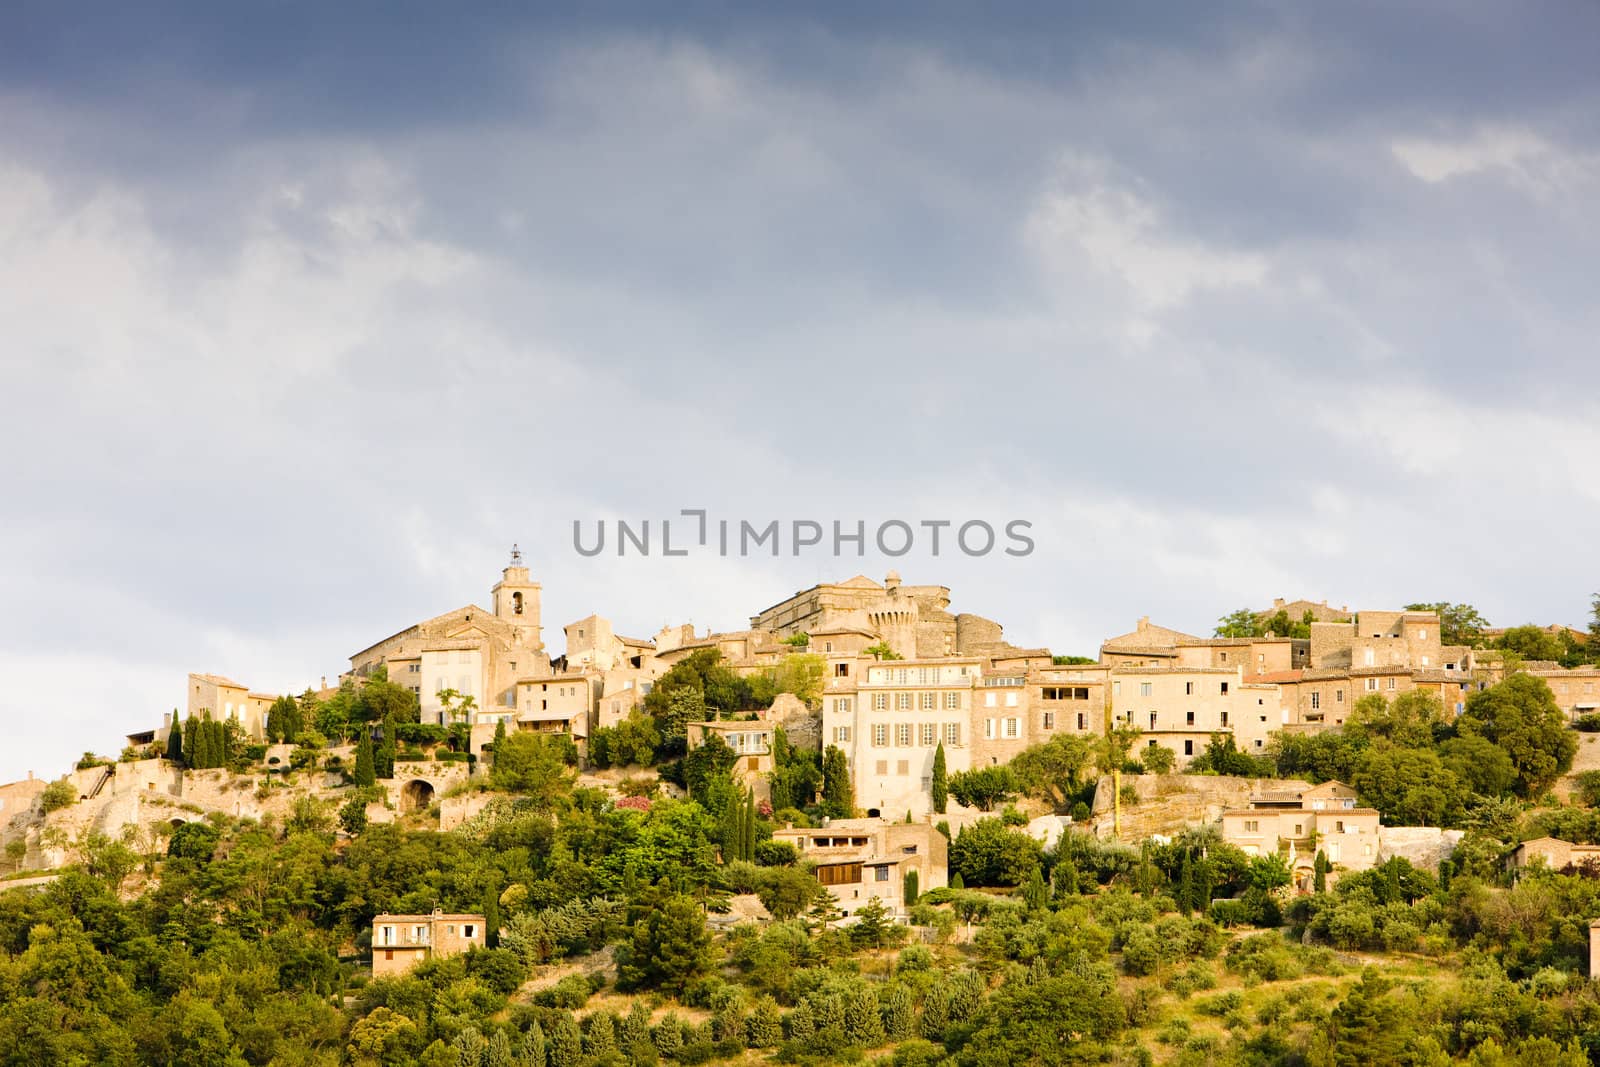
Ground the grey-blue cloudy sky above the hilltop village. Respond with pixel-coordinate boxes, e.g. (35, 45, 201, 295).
(0, 2, 1600, 781)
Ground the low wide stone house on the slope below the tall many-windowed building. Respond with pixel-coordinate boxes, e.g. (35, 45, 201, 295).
(773, 819, 949, 917)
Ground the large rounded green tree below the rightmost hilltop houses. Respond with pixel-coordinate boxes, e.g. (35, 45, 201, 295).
(1456, 673, 1578, 797)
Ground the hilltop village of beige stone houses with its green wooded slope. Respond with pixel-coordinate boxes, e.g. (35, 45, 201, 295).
(0, 550, 1600, 1067)
